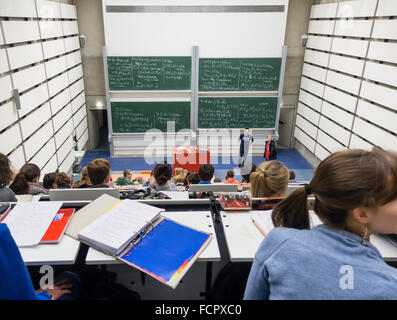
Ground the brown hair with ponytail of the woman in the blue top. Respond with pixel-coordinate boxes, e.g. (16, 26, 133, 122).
(272, 147, 397, 229)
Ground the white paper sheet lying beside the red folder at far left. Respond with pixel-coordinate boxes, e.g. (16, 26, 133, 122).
(3, 201, 62, 247)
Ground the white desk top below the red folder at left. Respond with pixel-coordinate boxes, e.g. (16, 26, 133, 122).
(19, 234, 80, 266)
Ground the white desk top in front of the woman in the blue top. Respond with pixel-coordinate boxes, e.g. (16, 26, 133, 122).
(221, 211, 397, 262)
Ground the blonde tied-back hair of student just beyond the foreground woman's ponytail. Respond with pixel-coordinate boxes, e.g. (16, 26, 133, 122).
(250, 161, 289, 198)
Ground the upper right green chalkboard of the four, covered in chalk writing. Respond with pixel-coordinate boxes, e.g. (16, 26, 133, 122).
(199, 58, 281, 91)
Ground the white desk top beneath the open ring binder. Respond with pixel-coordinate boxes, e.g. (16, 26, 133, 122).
(86, 211, 221, 264)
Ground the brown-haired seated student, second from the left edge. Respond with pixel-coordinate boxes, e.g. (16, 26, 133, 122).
(10, 163, 48, 195)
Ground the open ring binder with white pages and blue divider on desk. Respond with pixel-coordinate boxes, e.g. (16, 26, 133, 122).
(66, 195, 212, 288)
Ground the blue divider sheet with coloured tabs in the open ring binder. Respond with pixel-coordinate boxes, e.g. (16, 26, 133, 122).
(119, 219, 211, 287)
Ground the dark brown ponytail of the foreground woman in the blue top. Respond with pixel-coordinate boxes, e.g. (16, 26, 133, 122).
(272, 185, 311, 229)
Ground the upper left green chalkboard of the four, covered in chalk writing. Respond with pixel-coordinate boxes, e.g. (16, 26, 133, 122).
(107, 56, 192, 91)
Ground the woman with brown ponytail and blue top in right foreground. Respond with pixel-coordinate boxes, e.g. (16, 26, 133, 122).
(244, 148, 397, 300)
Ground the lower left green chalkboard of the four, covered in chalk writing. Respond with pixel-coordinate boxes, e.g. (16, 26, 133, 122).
(110, 101, 190, 133)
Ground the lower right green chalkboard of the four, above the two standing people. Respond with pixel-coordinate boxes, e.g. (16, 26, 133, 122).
(198, 97, 277, 128)
